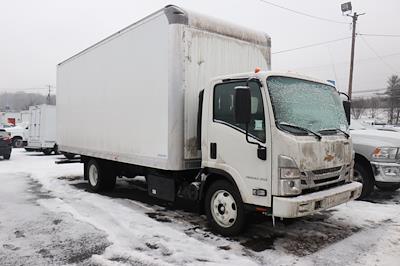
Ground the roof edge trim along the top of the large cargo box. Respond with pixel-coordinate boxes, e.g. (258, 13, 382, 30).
(58, 5, 271, 66)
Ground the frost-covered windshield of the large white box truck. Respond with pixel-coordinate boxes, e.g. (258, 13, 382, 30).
(267, 76, 348, 134)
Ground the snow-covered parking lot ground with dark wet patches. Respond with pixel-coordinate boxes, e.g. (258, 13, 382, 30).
(0, 149, 400, 265)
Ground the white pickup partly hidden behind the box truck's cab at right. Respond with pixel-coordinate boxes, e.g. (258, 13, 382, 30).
(350, 121, 400, 198)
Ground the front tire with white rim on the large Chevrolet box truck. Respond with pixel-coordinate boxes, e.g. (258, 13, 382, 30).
(204, 180, 245, 236)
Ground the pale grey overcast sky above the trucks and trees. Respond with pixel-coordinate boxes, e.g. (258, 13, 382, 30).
(0, 0, 400, 96)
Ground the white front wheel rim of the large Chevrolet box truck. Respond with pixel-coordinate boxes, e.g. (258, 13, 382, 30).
(211, 190, 237, 228)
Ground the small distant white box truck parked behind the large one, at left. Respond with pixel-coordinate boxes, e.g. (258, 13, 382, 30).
(25, 104, 58, 155)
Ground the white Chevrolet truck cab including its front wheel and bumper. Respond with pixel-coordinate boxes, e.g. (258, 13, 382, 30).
(200, 71, 362, 234)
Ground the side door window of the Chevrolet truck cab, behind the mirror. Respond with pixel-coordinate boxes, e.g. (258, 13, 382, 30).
(213, 81, 265, 142)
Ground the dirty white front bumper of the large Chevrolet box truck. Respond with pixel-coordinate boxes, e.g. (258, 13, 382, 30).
(272, 182, 362, 218)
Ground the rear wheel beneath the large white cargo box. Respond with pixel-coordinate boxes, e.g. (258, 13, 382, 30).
(85, 159, 116, 192)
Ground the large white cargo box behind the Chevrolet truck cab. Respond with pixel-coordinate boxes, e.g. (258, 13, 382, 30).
(57, 6, 271, 170)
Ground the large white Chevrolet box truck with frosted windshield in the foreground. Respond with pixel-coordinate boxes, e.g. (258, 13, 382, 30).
(57, 6, 362, 235)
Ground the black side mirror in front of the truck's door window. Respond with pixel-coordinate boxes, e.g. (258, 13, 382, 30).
(234, 86, 251, 125)
